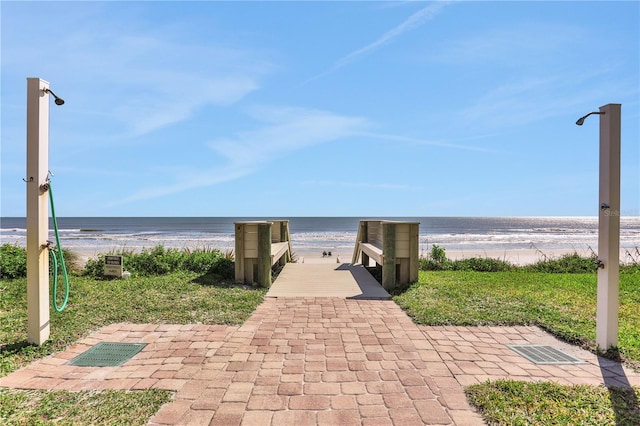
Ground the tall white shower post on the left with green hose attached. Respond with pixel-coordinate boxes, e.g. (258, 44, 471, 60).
(26, 78, 49, 345)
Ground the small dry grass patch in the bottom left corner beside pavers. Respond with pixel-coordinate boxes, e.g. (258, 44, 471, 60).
(0, 389, 171, 425)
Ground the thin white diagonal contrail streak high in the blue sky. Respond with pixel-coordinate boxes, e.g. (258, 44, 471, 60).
(302, 1, 451, 84)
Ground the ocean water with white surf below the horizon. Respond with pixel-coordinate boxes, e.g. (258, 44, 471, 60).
(0, 217, 640, 260)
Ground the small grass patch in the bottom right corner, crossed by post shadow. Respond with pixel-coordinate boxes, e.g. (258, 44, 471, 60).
(465, 380, 640, 426)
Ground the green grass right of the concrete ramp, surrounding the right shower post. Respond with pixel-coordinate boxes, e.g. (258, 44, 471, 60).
(394, 271, 640, 368)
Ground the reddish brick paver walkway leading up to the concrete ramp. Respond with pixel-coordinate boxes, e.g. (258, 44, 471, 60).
(0, 298, 640, 426)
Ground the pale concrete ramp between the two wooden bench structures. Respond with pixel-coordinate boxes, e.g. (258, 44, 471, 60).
(266, 263, 391, 299)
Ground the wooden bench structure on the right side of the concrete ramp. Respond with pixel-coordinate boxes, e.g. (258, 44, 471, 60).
(352, 220, 420, 290)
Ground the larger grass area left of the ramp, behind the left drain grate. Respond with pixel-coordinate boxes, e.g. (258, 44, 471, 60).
(0, 272, 266, 377)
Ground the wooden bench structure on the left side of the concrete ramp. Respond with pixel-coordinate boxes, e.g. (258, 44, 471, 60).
(234, 220, 291, 287)
